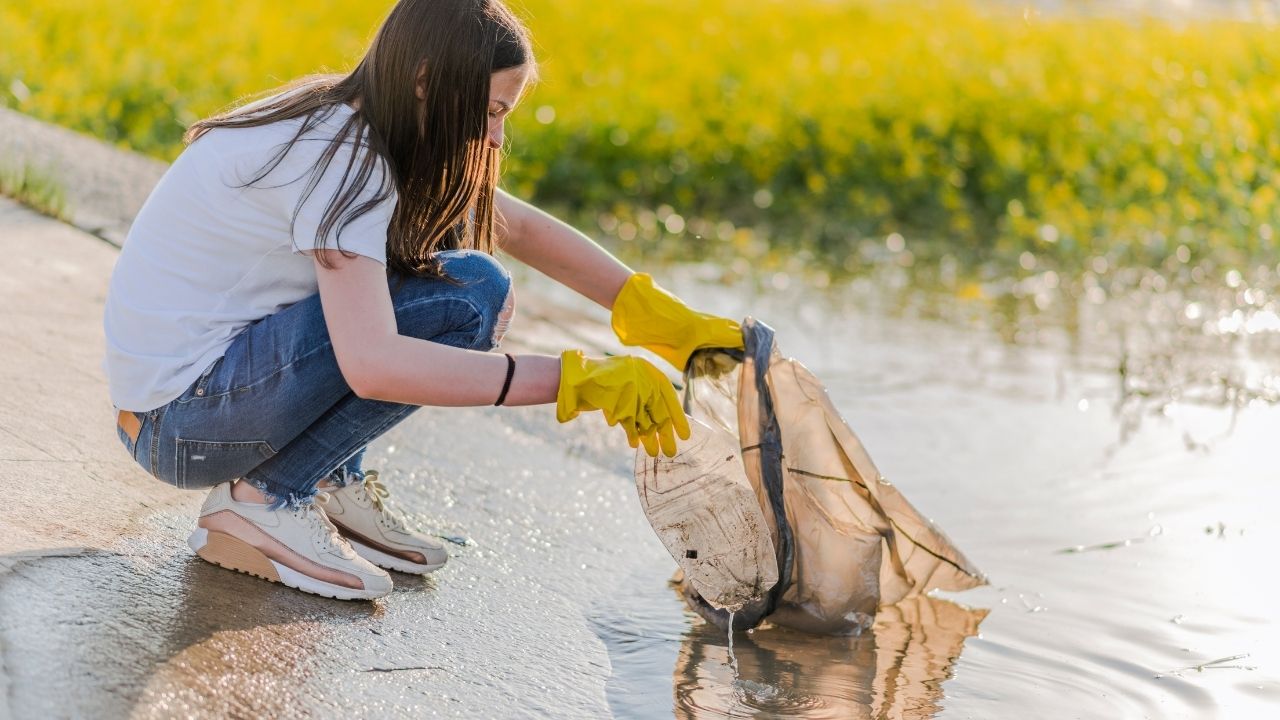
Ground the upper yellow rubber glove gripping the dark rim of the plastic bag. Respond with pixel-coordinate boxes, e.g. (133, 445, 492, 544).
(612, 273, 742, 372)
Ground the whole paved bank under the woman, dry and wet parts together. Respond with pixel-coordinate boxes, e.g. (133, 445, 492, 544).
(0, 116, 673, 717)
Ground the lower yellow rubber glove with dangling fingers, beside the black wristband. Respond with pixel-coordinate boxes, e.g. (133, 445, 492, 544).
(556, 350, 689, 457)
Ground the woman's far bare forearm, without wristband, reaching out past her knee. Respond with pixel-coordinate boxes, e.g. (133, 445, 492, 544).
(494, 190, 635, 307)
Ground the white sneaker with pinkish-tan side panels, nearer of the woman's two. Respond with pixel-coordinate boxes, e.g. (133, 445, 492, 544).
(187, 483, 392, 600)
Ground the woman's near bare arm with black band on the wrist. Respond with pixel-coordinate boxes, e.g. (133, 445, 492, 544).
(315, 250, 561, 406)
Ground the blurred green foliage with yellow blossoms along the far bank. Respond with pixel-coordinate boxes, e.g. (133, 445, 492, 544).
(0, 0, 1280, 269)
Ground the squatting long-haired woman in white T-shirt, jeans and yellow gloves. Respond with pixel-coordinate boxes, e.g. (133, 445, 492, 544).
(104, 0, 741, 598)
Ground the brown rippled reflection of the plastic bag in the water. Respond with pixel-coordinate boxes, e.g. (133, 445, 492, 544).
(675, 597, 987, 719)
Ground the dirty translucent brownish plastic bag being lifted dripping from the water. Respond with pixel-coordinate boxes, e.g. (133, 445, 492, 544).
(635, 318, 986, 633)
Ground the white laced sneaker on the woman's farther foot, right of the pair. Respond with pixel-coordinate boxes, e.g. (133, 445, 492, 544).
(324, 470, 449, 575)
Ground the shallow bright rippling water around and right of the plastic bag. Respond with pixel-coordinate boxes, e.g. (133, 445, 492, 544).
(583, 265, 1280, 719)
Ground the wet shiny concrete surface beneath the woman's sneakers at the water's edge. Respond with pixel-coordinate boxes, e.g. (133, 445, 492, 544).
(0, 410, 663, 717)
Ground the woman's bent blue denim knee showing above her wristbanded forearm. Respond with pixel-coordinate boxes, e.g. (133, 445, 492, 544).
(393, 250, 515, 350)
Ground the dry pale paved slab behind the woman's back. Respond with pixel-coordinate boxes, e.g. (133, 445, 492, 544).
(0, 200, 192, 550)
